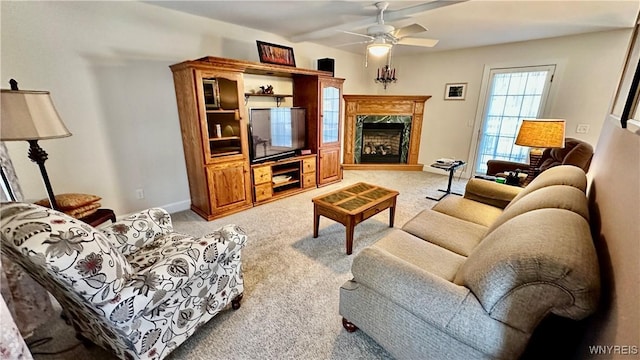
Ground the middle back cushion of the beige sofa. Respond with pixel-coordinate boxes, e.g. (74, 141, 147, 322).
(487, 185, 589, 234)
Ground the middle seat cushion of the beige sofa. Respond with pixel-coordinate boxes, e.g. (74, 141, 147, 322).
(402, 209, 487, 256)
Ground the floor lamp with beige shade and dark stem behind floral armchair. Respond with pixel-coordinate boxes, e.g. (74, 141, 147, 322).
(0, 79, 71, 209)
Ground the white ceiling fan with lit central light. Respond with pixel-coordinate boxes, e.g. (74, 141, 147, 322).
(338, 1, 438, 56)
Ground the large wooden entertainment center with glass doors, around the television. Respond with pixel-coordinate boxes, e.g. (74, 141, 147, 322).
(170, 56, 344, 220)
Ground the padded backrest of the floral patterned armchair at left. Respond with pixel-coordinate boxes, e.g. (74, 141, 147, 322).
(0, 203, 134, 303)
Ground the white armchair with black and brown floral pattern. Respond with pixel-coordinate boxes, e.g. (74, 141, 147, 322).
(0, 203, 247, 359)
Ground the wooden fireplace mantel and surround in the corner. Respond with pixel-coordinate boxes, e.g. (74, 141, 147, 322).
(342, 95, 431, 171)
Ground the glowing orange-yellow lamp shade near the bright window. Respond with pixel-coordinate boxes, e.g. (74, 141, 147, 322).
(516, 119, 565, 148)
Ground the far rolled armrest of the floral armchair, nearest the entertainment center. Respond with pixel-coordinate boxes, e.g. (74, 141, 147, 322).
(100, 208, 173, 255)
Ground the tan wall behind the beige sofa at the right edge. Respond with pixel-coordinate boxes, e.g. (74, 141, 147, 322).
(575, 117, 640, 359)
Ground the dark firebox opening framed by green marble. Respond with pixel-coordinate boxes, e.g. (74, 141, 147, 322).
(360, 123, 404, 164)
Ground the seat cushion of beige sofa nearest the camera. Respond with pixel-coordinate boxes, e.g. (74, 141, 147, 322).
(372, 229, 466, 281)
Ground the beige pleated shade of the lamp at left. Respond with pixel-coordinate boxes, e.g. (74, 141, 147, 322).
(0, 89, 71, 141)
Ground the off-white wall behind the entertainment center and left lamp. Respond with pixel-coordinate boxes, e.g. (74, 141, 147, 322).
(0, 1, 366, 214)
